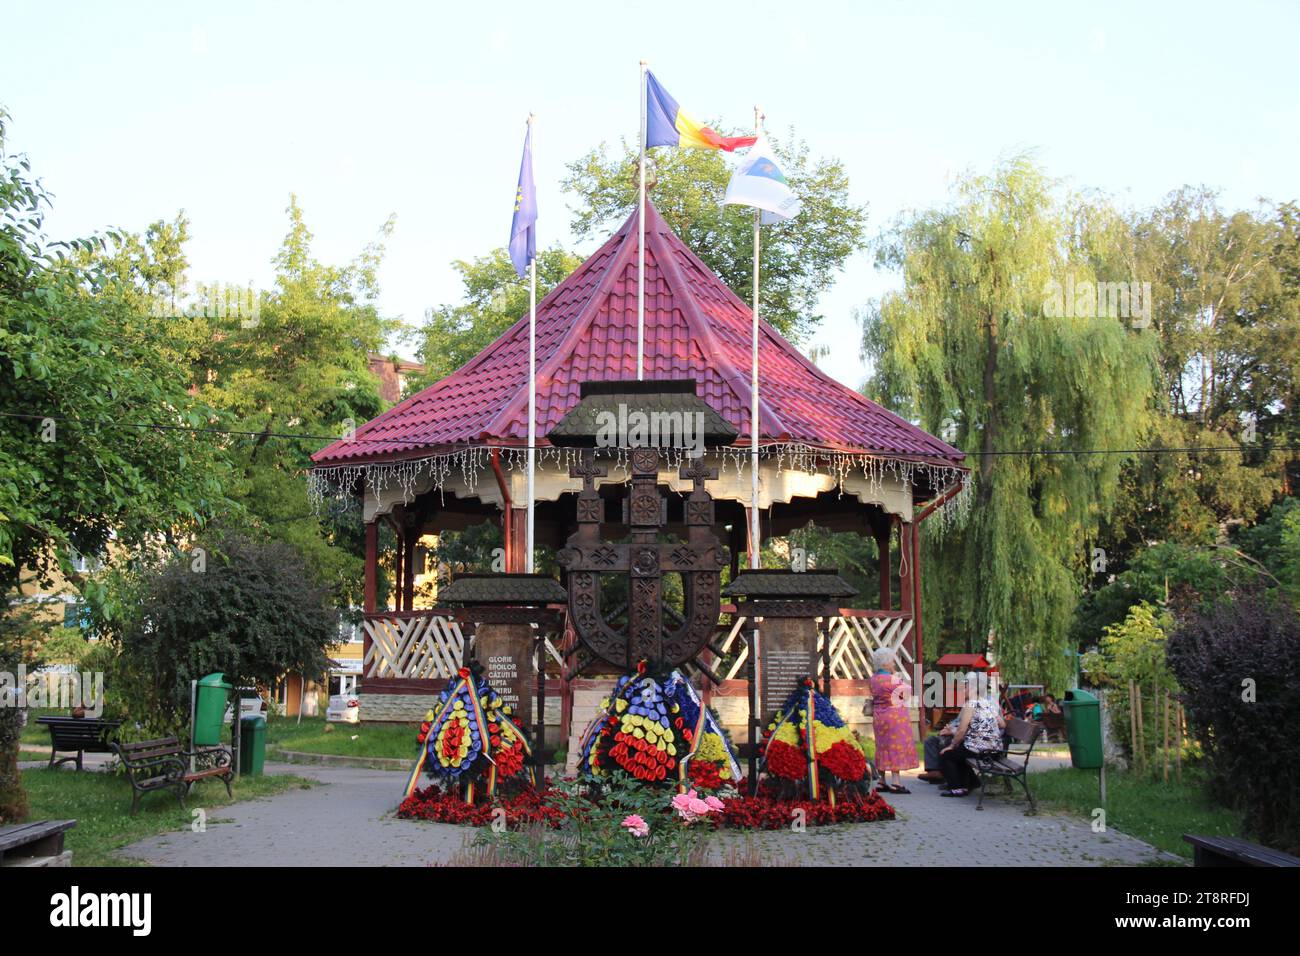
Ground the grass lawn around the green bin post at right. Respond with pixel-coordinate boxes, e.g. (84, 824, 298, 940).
(1030, 767, 1248, 860)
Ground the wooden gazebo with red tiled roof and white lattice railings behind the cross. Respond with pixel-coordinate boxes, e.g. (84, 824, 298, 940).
(311, 203, 966, 734)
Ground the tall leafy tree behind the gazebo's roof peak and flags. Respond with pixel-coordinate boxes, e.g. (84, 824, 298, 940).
(564, 131, 867, 342)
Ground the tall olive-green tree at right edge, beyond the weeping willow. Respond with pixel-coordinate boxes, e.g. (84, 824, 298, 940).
(1100, 187, 1300, 567)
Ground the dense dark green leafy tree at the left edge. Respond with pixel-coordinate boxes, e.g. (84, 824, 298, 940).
(0, 108, 229, 607)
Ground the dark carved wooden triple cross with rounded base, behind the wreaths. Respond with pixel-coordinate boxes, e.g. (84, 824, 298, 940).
(556, 447, 729, 670)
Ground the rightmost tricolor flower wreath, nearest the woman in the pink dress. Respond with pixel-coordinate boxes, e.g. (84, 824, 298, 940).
(762, 679, 871, 801)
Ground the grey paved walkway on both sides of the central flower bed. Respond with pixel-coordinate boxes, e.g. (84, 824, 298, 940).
(114, 761, 1175, 866)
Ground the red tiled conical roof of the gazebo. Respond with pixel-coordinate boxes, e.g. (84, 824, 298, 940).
(312, 203, 963, 466)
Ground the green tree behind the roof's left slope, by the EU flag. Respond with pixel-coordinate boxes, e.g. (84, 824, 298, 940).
(407, 246, 582, 394)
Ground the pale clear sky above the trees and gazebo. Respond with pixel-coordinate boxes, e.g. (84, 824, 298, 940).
(0, 0, 1300, 386)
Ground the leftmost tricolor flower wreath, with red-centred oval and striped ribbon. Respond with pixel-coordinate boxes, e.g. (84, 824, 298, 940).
(406, 667, 533, 804)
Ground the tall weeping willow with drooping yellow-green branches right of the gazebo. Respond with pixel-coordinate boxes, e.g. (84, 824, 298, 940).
(863, 157, 1154, 688)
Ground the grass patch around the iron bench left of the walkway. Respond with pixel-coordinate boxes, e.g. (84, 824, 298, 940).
(22, 769, 313, 866)
